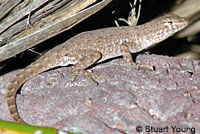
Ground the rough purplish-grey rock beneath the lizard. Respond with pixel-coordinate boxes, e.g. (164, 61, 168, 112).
(0, 55, 200, 134)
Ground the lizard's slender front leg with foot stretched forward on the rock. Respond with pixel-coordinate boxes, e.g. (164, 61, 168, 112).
(120, 43, 154, 70)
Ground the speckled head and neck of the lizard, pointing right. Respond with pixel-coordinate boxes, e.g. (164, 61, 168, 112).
(141, 13, 188, 47)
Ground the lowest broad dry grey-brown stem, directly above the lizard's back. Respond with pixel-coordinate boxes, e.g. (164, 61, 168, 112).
(0, 0, 112, 62)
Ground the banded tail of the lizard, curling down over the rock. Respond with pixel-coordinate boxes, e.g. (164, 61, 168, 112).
(6, 58, 50, 124)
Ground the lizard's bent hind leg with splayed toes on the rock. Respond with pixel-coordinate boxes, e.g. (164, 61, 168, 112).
(71, 51, 103, 85)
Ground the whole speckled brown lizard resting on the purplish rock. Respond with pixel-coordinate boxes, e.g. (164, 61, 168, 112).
(6, 13, 188, 123)
